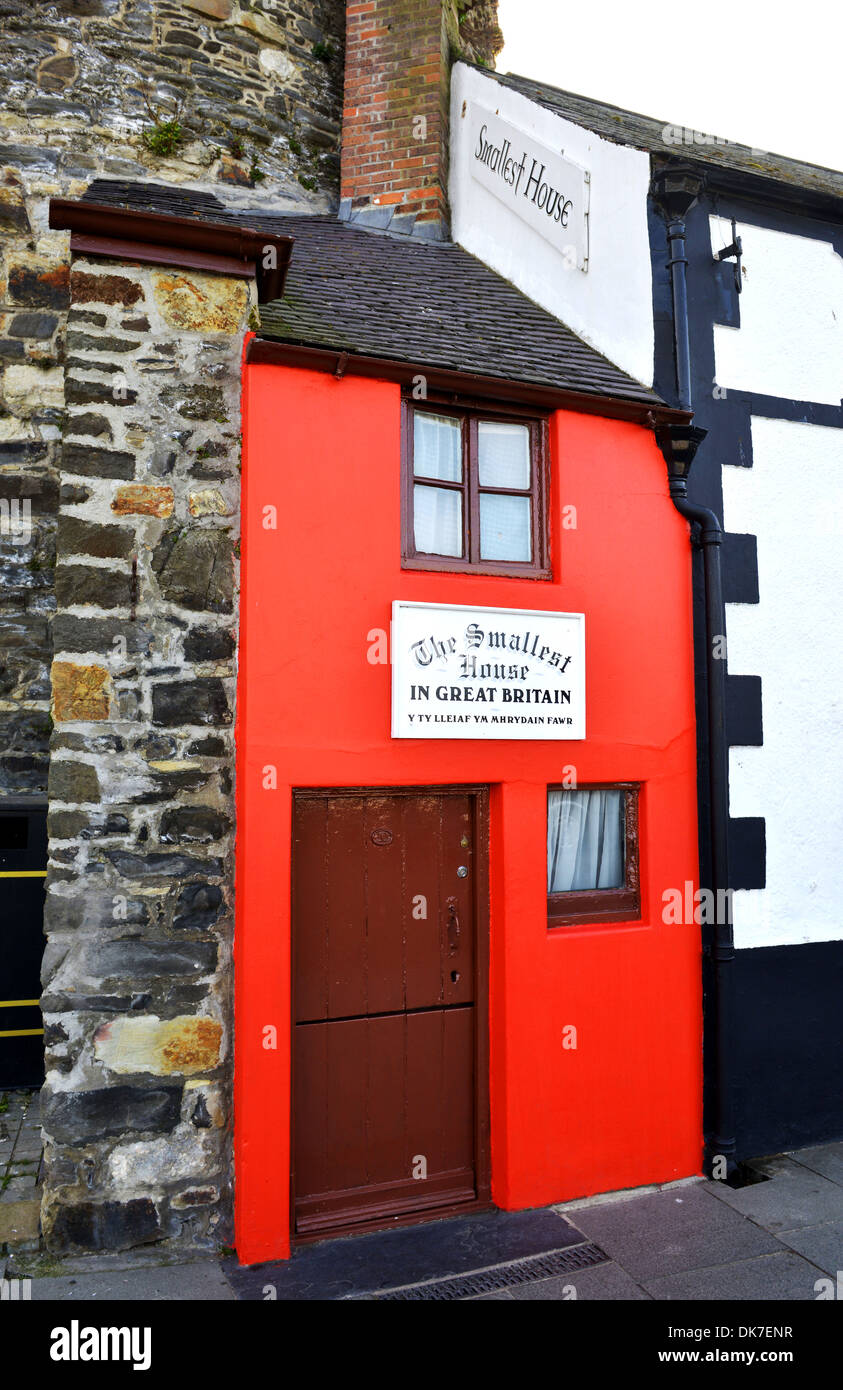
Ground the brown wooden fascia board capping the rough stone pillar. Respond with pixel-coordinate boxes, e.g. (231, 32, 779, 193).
(49, 197, 294, 304)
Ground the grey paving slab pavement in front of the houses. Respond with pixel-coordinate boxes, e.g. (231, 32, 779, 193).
(8, 1144, 843, 1302)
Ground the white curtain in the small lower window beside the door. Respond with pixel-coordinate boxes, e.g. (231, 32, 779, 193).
(547, 790, 623, 892)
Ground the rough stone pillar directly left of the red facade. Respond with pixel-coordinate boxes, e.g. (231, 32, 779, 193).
(42, 259, 255, 1251)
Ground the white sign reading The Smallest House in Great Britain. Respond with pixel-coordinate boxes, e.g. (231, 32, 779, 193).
(392, 602, 586, 738)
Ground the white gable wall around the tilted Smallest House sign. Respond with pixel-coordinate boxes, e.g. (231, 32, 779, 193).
(449, 63, 656, 386)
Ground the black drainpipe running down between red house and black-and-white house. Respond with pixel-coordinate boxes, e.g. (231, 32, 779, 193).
(652, 165, 737, 1179)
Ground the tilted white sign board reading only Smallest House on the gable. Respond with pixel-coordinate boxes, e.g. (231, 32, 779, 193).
(469, 106, 590, 270)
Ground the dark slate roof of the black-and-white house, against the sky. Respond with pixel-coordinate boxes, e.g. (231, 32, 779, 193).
(475, 64, 843, 200)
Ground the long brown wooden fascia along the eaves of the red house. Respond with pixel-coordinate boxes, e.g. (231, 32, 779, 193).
(246, 338, 693, 430)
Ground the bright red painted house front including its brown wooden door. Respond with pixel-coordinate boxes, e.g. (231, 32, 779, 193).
(235, 325, 703, 1262)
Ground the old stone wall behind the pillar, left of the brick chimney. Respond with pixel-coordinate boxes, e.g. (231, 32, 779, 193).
(0, 0, 345, 796)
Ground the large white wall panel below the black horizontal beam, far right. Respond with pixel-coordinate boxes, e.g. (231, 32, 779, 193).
(718, 417, 843, 947)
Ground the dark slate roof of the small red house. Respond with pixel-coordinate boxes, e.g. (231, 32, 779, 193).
(85, 179, 664, 406)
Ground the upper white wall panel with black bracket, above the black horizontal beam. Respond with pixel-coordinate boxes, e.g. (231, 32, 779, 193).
(709, 217, 843, 406)
